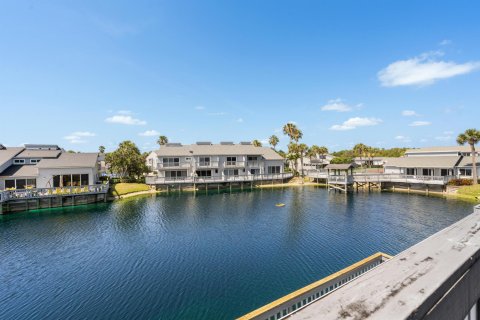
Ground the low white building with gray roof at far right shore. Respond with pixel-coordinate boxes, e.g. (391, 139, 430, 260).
(384, 146, 480, 178)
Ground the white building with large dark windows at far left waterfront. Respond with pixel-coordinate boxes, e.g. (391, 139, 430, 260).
(0, 144, 99, 190)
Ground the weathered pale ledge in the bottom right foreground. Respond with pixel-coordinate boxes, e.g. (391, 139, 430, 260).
(289, 206, 480, 320)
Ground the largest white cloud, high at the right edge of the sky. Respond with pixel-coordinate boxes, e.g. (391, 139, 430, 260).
(377, 52, 480, 87)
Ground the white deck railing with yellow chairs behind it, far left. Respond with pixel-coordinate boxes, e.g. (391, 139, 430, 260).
(0, 184, 109, 202)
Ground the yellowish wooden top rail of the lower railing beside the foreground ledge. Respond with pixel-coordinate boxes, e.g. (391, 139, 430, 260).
(237, 252, 392, 320)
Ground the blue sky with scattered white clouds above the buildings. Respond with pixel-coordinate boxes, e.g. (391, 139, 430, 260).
(0, 0, 480, 151)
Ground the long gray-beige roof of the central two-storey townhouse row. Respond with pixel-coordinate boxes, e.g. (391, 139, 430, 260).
(155, 144, 283, 160)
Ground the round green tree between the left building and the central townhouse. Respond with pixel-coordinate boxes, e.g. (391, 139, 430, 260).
(105, 141, 148, 182)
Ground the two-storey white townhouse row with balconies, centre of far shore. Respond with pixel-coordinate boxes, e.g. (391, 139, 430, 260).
(147, 142, 285, 184)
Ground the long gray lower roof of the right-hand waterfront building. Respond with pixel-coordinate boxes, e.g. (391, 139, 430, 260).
(385, 156, 461, 168)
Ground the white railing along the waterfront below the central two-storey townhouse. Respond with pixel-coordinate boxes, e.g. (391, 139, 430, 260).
(145, 173, 293, 184)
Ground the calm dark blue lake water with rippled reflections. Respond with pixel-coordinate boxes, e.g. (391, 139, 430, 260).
(0, 187, 473, 319)
